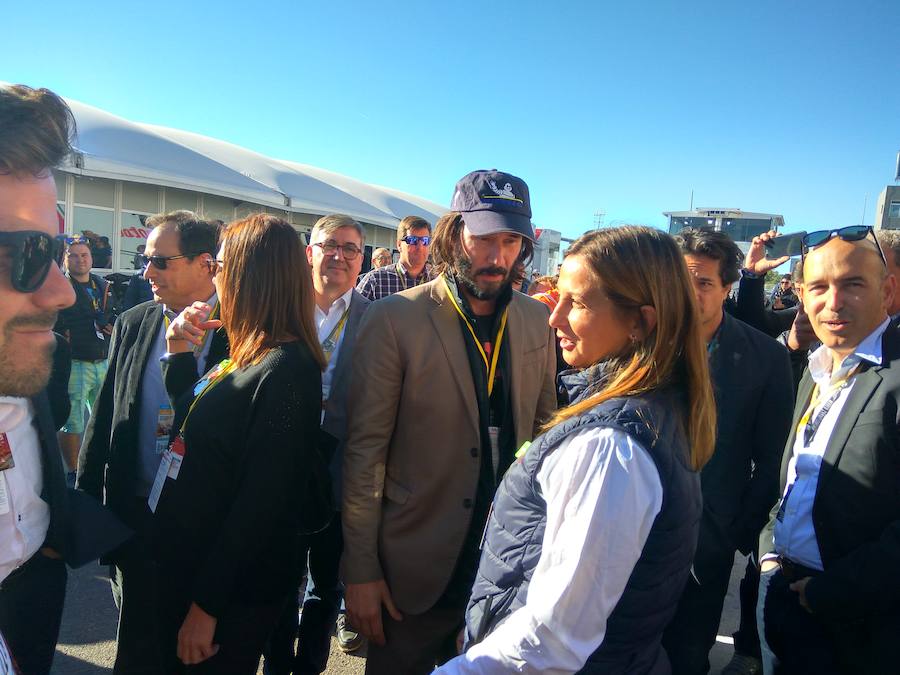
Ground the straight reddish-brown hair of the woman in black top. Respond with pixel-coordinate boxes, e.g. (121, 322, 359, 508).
(219, 213, 325, 369)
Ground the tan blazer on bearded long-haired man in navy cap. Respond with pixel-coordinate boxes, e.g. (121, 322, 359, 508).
(342, 277, 556, 614)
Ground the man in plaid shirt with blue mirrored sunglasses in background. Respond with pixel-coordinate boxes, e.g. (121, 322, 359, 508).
(356, 216, 434, 300)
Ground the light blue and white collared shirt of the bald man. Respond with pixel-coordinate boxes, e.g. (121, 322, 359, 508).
(775, 319, 890, 570)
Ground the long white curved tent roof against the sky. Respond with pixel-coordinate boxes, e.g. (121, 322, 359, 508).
(53, 92, 447, 227)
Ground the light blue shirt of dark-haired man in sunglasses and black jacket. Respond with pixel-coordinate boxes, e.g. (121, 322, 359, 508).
(136, 293, 218, 497)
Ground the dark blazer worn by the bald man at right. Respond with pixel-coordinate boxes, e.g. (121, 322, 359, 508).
(760, 324, 900, 628)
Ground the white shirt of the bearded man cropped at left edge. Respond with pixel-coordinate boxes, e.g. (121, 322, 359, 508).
(0, 396, 50, 581)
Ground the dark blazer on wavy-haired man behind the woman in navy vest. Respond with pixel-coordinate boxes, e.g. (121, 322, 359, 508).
(694, 314, 794, 580)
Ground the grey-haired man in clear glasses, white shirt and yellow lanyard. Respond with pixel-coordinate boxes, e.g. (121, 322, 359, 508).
(265, 214, 370, 675)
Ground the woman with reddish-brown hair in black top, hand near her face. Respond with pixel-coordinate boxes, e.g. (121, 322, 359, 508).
(150, 214, 324, 675)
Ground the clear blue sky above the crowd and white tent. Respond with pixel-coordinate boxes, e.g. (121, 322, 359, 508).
(0, 0, 900, 236)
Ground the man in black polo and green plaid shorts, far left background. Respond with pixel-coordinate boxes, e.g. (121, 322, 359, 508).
(54, 238, 115, 486)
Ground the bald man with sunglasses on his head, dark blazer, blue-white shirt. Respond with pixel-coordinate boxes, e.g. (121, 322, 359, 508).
(757, 229, 900, 675)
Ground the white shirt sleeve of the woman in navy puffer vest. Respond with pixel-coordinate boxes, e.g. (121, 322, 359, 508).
(435, 428, 663, 675)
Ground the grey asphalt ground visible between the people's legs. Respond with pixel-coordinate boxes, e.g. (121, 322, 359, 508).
(51, 557, 745, 675)
